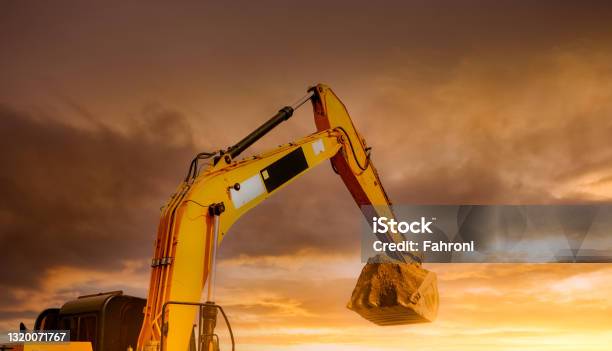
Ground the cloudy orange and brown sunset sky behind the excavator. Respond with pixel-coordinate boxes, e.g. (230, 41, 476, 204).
(0, 0, 612, 351)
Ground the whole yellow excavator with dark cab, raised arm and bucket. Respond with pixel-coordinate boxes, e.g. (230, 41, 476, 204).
(0, 84, 438, 351)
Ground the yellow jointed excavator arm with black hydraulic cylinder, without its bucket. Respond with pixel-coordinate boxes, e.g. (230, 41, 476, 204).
(137, 85, 436, 351)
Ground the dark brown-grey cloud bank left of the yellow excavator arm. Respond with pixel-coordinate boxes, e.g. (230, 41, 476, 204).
(0, 106, 194, 288)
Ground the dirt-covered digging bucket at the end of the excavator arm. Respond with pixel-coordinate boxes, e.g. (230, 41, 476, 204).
(347, 260, 439, 325)
